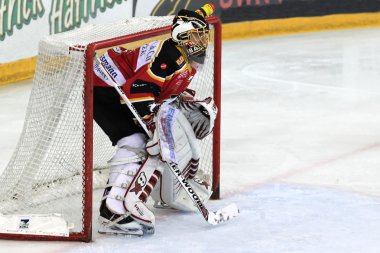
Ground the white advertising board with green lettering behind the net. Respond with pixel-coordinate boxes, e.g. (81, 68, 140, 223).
(0, 0, 159, 64)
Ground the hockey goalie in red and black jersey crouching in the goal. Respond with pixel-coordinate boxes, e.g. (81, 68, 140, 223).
(94, 4, 217, 235)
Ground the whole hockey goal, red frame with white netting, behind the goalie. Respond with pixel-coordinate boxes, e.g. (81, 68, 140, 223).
(0, 16, 220, 241)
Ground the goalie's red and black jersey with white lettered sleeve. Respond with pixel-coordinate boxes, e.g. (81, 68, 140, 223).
(94, 39, 196, 115)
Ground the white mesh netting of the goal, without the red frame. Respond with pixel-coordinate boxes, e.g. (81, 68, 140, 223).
(0, 16, 214, 232)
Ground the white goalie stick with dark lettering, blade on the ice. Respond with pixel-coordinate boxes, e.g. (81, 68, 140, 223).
(95, 56, 239, 225)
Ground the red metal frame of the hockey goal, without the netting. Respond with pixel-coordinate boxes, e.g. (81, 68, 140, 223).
(0, 16, 222, 242)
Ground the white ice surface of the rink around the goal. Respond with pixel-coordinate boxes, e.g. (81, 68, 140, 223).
(0, 28, 380, 253)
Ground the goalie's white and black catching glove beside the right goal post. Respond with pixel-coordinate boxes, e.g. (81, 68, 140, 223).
(180, 97, 218, 139)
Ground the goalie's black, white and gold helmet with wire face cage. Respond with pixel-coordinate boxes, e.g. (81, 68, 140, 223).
(172, 9, 210, 63)
